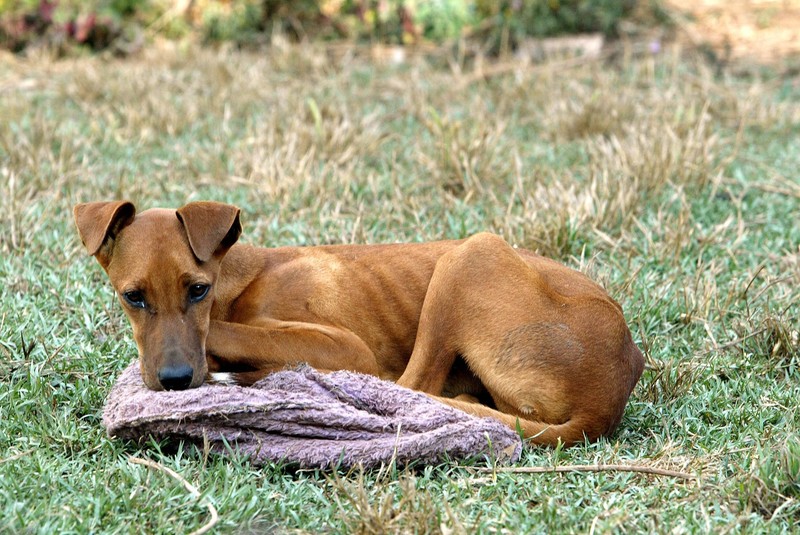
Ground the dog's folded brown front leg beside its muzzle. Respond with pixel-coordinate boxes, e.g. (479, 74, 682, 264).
(206, 319, 380, 383)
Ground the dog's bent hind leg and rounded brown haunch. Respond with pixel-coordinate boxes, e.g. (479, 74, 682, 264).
(398, 234, 641, 444)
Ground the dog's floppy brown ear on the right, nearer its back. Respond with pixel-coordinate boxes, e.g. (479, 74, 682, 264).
(178, 201, 242, 262)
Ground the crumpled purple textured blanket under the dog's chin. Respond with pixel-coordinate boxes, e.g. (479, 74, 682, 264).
(103, 362, 522, 468)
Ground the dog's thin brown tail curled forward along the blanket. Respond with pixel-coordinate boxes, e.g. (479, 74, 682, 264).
(433, 396, 604, 446)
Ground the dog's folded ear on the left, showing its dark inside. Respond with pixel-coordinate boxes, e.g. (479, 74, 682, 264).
(72, 201, 136, 268)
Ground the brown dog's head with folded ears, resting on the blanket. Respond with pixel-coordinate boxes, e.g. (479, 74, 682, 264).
(74, 201, 242, 390)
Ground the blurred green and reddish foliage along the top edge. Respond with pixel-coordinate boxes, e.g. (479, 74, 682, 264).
(0, 0, 657, 51)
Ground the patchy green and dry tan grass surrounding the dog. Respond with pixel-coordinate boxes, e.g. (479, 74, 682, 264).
(0, 40, 800, 533)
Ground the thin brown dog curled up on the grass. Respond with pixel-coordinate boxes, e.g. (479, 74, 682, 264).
(74, 201, 644, 444)
